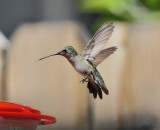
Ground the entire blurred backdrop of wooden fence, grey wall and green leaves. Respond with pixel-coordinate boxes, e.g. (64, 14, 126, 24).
(0, 0, 160, 130)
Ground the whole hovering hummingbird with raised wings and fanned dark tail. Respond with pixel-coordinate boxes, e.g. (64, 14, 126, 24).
(39, 21, 117, 99)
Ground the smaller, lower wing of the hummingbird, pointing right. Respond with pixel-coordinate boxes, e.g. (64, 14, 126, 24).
(91, 46, 117, 66)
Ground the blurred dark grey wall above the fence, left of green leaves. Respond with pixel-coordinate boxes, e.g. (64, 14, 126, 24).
(0, 0, 78, 37)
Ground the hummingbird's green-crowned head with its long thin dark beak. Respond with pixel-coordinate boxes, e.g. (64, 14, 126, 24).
(39, 46, 77, 60)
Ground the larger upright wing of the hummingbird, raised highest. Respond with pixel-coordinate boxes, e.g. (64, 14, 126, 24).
(82, 22, 114, 59)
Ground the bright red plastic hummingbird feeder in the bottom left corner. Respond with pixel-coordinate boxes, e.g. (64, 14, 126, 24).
(0, 101, 56, 130)
